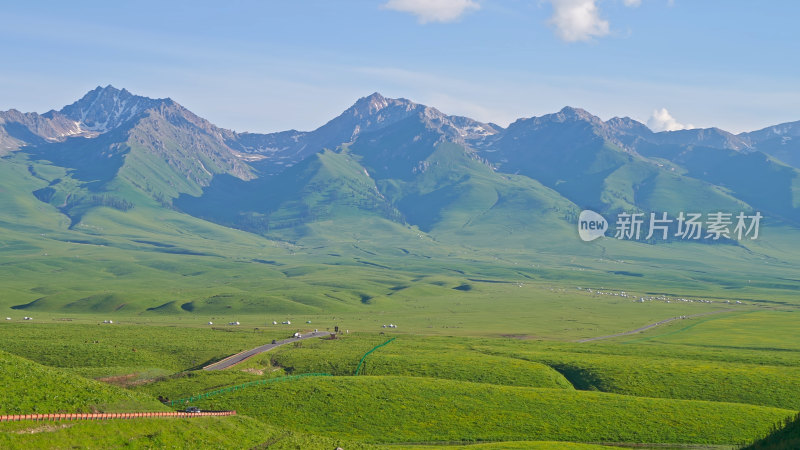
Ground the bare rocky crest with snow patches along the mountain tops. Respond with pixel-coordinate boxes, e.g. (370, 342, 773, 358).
(6, 84, 800, 157)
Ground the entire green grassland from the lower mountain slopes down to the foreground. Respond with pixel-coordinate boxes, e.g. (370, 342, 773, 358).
(0, 146, 800, 448)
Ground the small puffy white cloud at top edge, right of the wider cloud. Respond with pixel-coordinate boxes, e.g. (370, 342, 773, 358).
(549, 0, 609, 42)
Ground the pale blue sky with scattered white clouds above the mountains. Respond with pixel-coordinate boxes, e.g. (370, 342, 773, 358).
(0, 0, 800, 132)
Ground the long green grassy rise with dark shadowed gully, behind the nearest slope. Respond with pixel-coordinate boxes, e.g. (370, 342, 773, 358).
(263, 330, 800, 409)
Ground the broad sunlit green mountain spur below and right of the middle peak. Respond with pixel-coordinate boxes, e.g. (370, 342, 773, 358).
(358, 143, 578, 250)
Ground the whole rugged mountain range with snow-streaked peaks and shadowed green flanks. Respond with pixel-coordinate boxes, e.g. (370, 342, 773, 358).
(0, 86, 800, 239)
